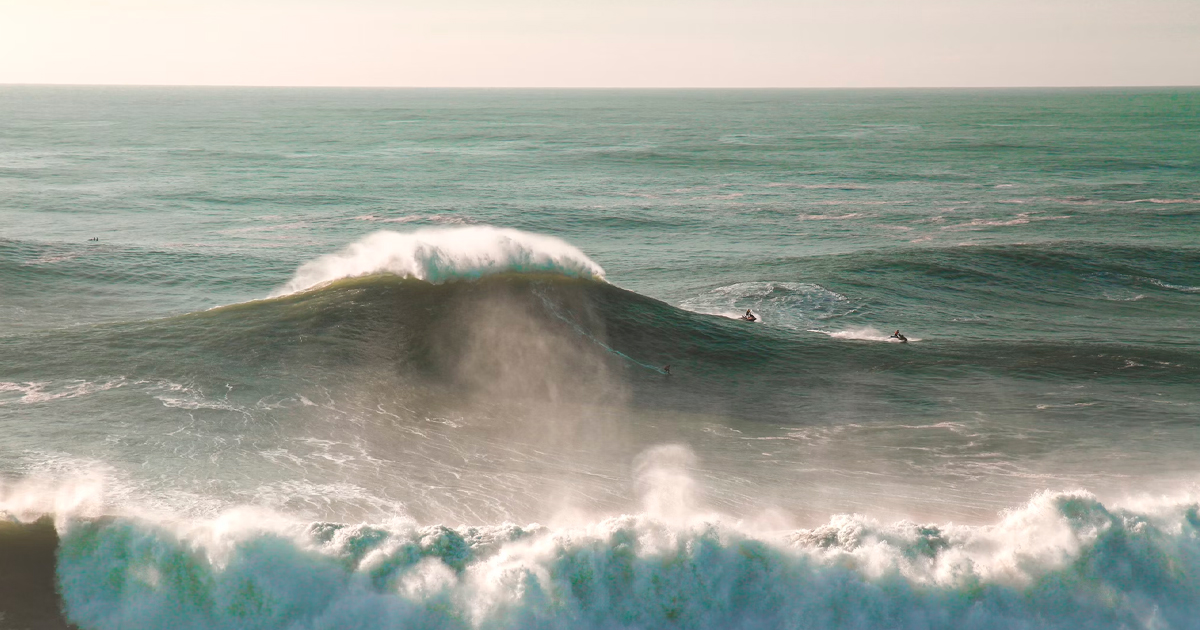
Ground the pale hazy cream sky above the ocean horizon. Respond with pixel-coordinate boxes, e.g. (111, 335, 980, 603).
(0, 0, 1200, 86)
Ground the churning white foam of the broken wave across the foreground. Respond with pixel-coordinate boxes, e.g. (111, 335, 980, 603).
(0, 445, 1200, 630)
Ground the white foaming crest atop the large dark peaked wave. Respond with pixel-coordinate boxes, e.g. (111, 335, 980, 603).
(270, 226, 605, 298)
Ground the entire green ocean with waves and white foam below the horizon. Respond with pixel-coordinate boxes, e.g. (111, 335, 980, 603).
(0, 85, 1200, 630)
